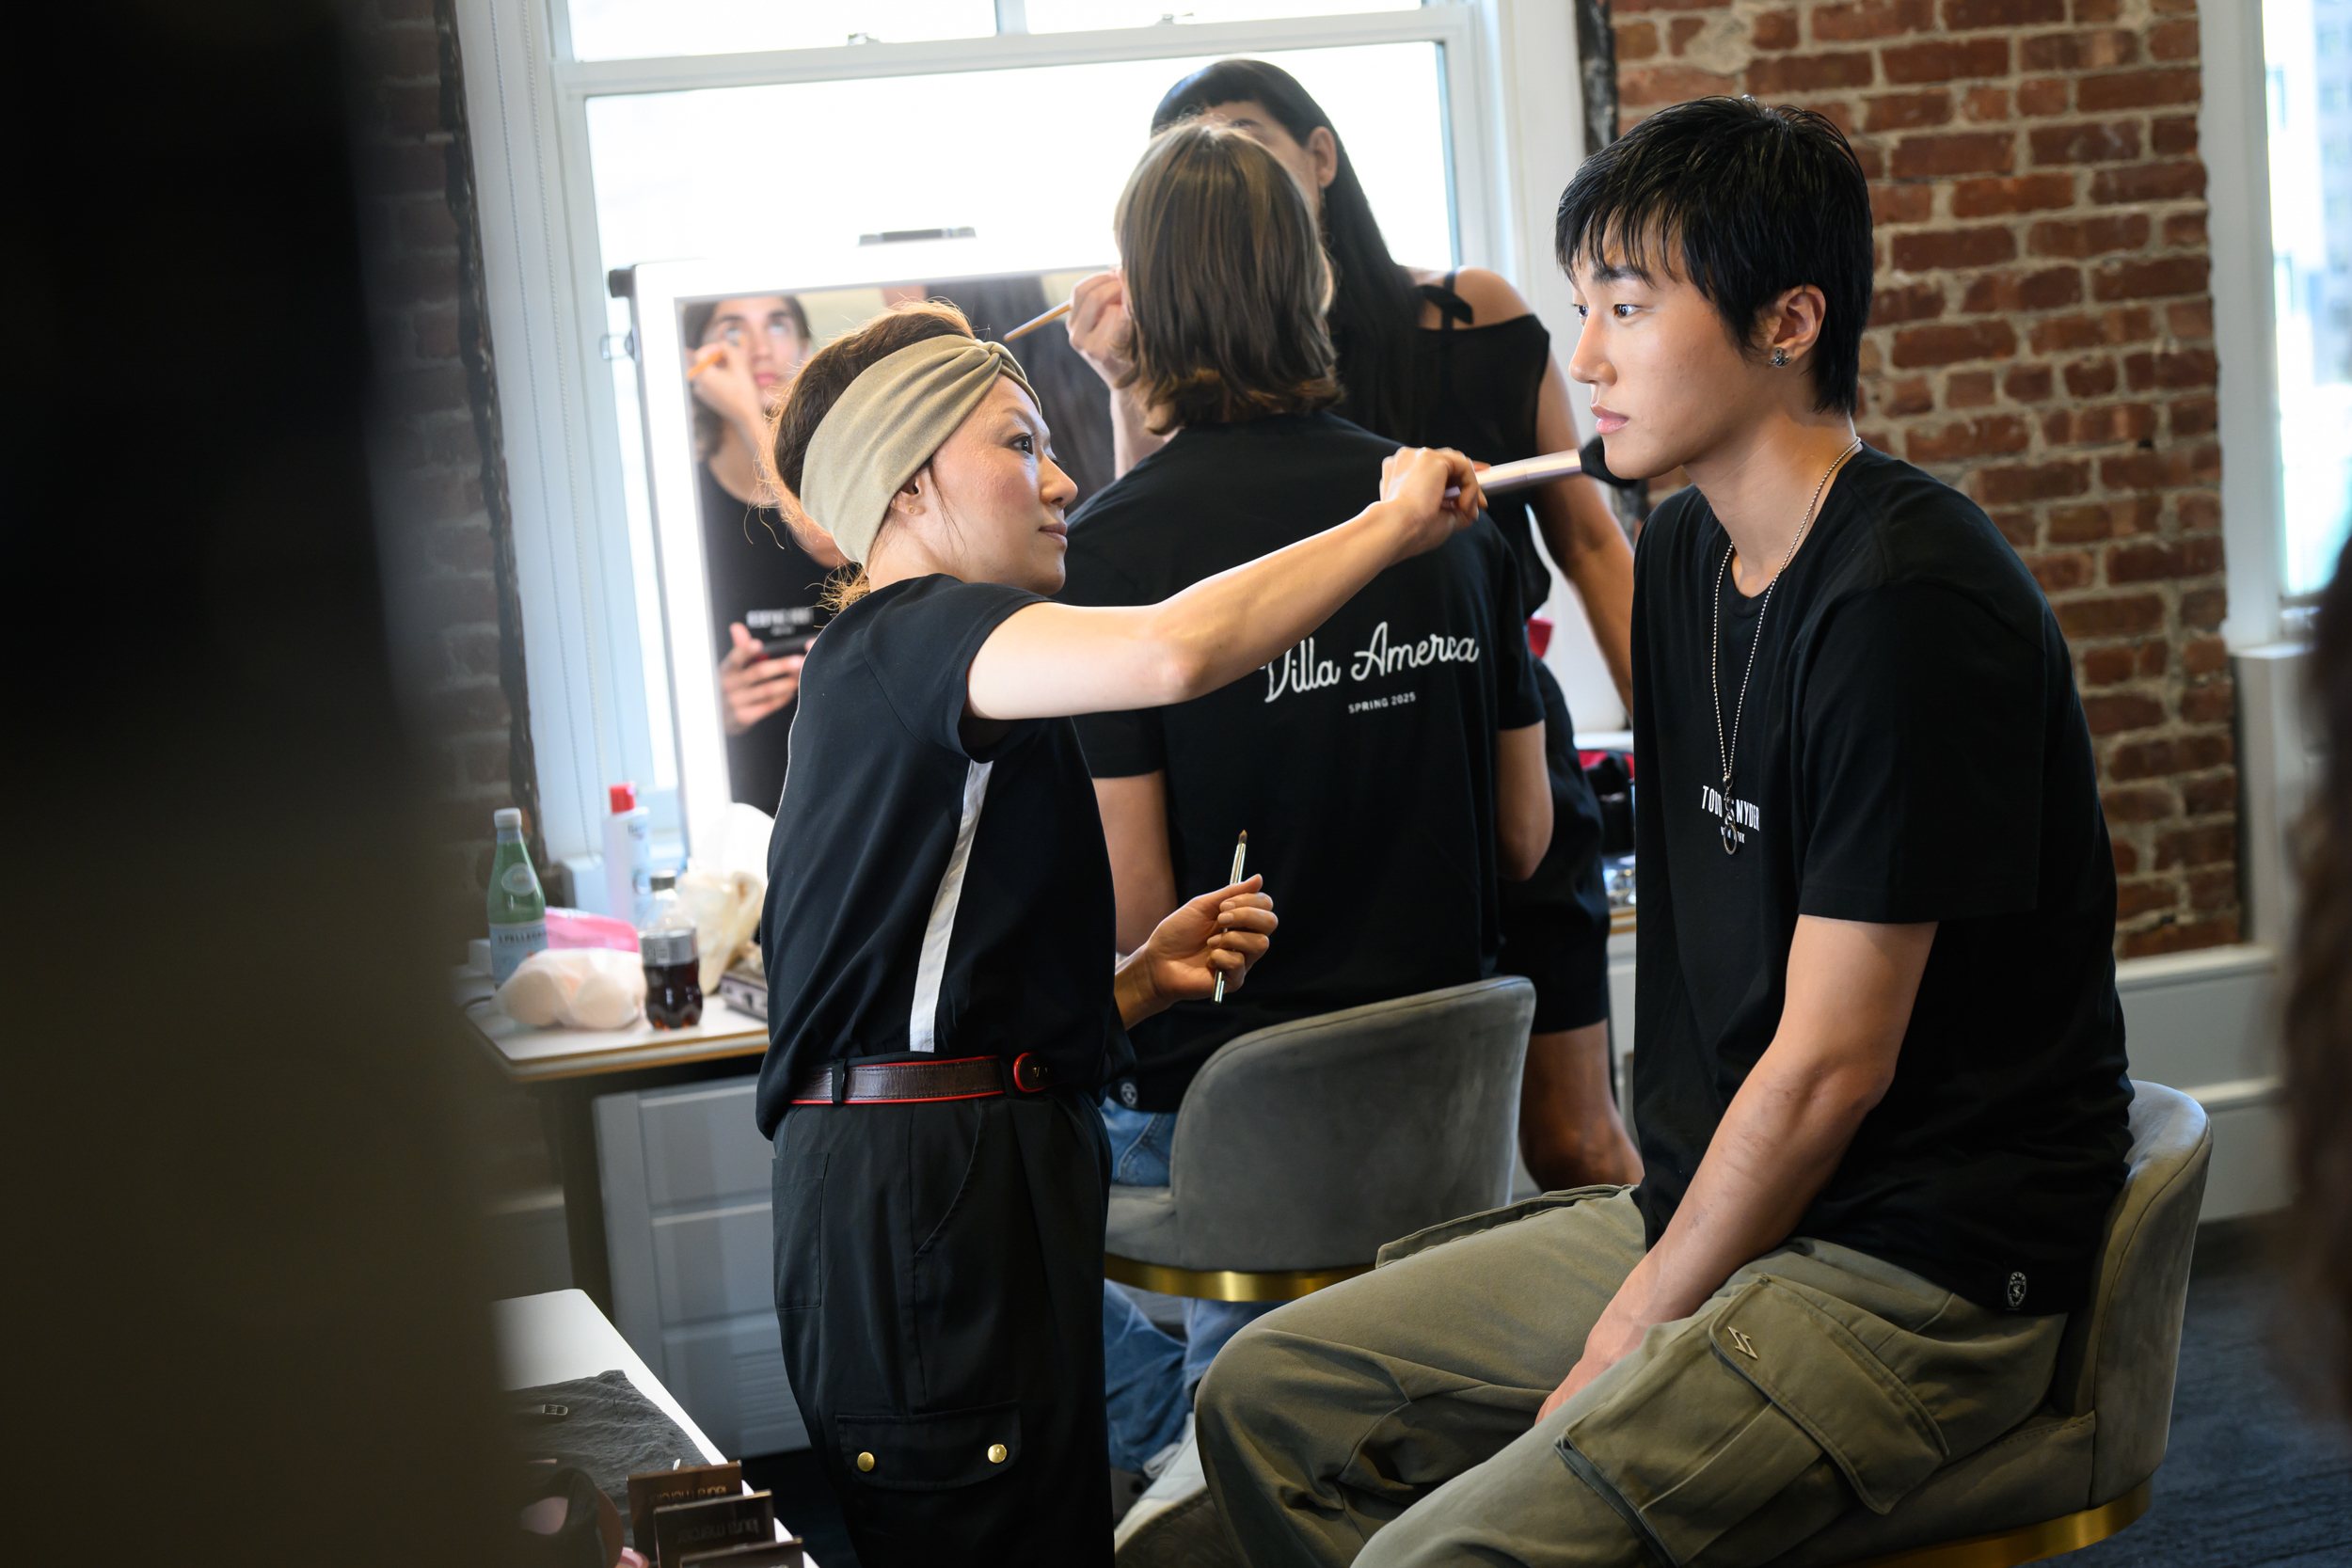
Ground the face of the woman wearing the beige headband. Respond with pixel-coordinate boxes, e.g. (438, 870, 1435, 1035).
(913, 376, 1077, 594)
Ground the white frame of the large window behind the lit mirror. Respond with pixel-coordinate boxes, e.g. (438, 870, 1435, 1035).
(456, 0, 1583, 863)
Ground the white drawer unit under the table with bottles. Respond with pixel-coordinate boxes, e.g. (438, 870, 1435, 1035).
(596, 1077, 809, 1458)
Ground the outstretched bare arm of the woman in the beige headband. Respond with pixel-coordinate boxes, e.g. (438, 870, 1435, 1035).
(967, 449, 1482, 721)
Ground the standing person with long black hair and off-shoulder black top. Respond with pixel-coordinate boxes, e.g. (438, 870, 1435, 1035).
(1071, 58, 1642, 1187)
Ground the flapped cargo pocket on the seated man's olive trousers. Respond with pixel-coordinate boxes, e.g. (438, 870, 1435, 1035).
(1557, 1279, 1946, 1563)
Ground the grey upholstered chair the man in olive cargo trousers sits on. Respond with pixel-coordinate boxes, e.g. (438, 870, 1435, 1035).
(1773, 1082, 2214, 1568)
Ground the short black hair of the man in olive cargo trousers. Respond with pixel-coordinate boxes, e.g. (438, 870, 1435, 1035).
(1555, 99, 1870, 414)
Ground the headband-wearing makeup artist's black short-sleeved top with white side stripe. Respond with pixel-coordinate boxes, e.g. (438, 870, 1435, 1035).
(760, 576, 1129, 1135)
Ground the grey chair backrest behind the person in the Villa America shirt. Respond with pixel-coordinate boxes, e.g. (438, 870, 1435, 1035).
(1169, 978, 1536, 1270)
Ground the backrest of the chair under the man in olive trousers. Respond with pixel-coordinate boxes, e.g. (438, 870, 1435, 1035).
(2051, 1079, 2214, 1507)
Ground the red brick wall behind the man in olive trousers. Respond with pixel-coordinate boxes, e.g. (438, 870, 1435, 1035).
(1613, 0, 2239, 957)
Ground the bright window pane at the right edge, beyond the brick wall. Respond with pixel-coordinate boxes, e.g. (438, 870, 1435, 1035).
(2263, 0, 2352, 594)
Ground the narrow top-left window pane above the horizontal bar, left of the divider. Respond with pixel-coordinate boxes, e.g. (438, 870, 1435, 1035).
(572, 0, 997, 58)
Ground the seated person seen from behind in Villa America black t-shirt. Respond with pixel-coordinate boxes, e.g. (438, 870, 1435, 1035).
(1063, 122, 1552, 1532)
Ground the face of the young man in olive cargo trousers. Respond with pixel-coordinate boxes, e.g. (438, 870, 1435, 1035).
(1569, 246, 1769, 480)
